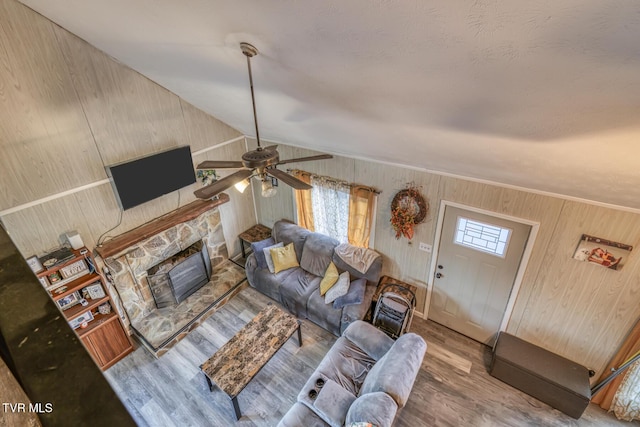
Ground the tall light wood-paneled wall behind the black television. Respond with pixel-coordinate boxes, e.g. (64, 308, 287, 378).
(0, 0, 256, 256)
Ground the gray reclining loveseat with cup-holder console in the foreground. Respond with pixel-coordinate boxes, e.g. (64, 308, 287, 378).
(278, 321, 427, 427)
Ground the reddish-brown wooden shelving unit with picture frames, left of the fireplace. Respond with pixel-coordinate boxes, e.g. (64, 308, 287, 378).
(36, 248, 133, 370)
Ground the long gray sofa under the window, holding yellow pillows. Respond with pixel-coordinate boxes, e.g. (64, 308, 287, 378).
(245, 221, 382, 336)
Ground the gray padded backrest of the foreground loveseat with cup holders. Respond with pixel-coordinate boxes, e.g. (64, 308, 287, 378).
(360, 333, 427, 408)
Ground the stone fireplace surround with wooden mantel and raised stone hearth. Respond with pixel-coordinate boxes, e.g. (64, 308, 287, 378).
(96, 199, 246, 357)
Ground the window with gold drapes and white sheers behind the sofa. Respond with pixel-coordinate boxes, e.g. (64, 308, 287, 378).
(292, 170, 377, 248)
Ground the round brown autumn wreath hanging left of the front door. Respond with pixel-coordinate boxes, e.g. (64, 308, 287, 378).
(391, 183, 429, 240)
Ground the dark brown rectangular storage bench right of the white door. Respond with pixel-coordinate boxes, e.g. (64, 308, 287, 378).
(489, 332, 591, 419)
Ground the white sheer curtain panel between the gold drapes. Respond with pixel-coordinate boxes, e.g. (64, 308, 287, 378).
(311, 175, 350, 243)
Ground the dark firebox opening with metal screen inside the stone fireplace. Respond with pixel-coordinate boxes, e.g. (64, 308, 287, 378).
(147, 241, 211, 308)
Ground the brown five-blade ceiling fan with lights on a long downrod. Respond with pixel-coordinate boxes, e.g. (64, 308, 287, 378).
(193, 43, 333, 199)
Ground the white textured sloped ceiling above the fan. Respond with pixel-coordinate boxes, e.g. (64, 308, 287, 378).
(17, 0, 640, 209)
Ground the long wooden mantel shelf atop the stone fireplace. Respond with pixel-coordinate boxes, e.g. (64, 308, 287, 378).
(96, 193, 229, 259)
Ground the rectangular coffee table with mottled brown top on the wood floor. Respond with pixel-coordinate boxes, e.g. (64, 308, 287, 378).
(200, 304, 302, 420)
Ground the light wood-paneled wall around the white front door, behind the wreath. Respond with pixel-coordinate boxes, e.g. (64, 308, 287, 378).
(256, 145, 640, 378)
